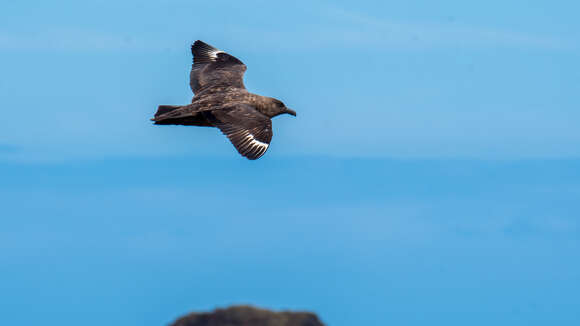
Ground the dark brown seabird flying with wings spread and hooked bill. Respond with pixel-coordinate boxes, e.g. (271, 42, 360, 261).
(151, 40, 296, 160)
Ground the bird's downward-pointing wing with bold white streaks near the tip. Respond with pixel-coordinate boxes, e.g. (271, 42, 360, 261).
(203, 104, 272, 160)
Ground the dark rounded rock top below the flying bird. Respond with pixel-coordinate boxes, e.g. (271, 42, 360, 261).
(171, 306, 324, 326)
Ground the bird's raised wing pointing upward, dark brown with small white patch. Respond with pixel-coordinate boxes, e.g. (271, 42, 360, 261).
(189, 40, 246, 93)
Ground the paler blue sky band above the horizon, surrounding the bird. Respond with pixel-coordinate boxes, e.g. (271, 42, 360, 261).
(0, 1, 580, 161)
